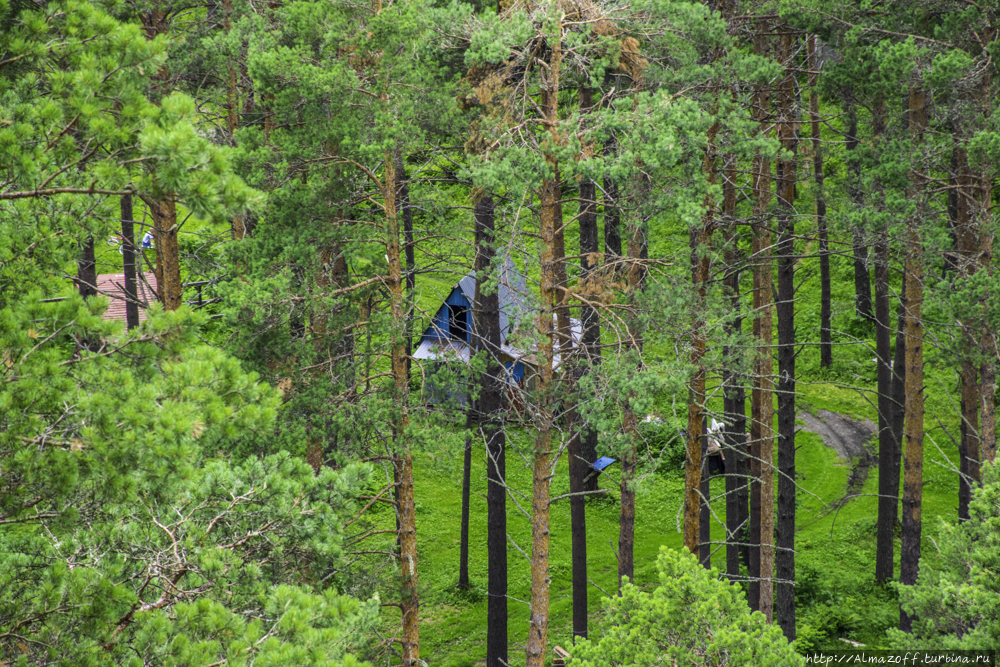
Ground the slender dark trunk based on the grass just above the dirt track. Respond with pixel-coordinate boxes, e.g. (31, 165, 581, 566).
(807, 35, 833, 368)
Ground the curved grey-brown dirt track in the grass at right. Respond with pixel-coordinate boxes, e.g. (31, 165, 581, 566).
(796, 410, 878, 509)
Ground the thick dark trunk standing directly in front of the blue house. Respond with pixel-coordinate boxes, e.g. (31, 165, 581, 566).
(474, 194, 507, 667)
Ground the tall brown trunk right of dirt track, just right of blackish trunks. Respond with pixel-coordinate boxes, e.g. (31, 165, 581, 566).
(899, 87, 927, 632)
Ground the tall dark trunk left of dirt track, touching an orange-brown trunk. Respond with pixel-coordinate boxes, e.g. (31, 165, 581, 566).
(775, 29, 798, 641)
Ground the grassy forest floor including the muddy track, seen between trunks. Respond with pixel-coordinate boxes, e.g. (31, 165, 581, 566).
(374, 374, 958, 667)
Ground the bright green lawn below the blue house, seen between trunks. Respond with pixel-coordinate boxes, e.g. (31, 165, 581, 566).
(398, 430, 683, 667)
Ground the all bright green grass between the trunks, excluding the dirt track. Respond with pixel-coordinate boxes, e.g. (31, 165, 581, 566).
(374, 205, 958, 667)
